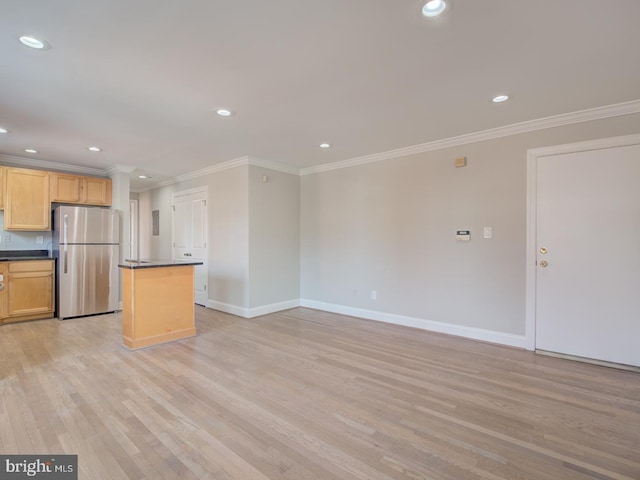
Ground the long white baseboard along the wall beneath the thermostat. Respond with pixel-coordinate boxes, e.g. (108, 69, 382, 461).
(300, 298, 525, 348)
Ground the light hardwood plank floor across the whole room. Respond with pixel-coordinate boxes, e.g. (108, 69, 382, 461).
(0, 307, 640, 480)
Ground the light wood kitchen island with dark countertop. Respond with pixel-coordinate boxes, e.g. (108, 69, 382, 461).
(118, 260, 202, 350)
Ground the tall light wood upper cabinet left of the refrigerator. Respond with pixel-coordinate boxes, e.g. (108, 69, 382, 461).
(4, 167, 51, 231)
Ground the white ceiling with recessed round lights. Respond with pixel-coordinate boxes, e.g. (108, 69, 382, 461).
(0, 0, 640, 190)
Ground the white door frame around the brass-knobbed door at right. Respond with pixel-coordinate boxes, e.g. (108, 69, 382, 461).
(525, 134, 640, 350)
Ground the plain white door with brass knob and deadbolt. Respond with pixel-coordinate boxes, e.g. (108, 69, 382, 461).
(535, 145, 640, 366)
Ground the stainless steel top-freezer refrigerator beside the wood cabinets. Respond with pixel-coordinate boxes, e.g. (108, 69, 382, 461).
(53, 206, 120, 319)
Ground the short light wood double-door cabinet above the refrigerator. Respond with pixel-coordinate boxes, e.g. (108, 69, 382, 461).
(51, 172, 111, 206)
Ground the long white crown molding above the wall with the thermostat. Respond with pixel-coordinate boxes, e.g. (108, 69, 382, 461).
(300, 100, 640, 176)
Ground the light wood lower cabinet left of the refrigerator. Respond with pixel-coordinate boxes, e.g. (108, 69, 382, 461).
(0, 260, 55, 323)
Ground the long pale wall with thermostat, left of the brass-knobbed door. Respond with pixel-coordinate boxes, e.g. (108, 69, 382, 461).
(301, 114, 640, 344)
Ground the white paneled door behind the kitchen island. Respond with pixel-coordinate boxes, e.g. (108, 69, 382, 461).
(173, 190, 208, 306)
